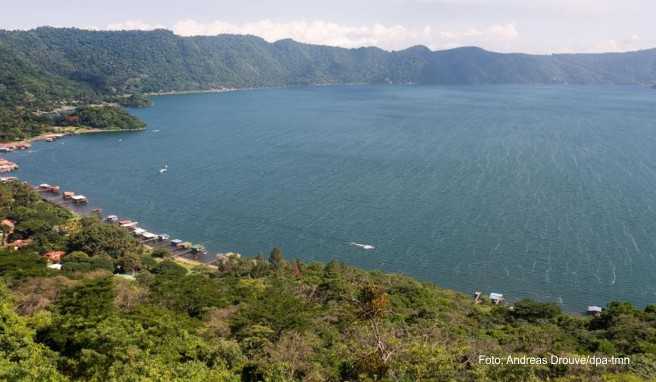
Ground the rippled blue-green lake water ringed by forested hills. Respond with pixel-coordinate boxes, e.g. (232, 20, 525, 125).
(9, 86, 656, 310)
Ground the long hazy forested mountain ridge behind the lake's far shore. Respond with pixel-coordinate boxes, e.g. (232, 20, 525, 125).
(0, 27, 656, 103)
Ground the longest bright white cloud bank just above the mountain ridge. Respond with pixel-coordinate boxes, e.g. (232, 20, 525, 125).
(173, 19, 519, 50)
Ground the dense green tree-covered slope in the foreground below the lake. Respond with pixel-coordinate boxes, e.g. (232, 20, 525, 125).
(0, 183, 656, 381)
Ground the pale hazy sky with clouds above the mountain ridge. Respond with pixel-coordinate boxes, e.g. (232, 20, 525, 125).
(0, 0, 656, 53)
